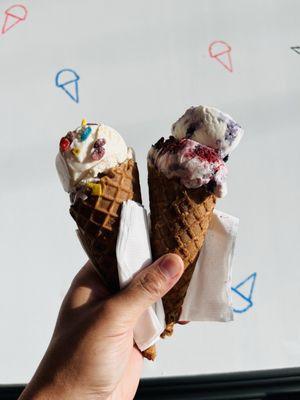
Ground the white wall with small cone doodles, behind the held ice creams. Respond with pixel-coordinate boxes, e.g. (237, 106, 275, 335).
(0, 0, 300, 383)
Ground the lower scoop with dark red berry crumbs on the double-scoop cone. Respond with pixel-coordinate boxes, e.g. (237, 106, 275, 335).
(148, 136, 227, 197)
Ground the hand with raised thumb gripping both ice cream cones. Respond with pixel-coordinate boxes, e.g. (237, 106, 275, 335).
(19, 254, 183, 400)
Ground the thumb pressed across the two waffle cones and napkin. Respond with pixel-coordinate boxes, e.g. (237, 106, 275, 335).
(114, 254, 184, 325)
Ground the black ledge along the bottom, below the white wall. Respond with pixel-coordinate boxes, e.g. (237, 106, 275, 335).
(0, 368, 300, 400)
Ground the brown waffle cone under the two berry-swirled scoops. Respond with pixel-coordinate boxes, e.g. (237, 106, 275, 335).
(148, 166, 216, 337)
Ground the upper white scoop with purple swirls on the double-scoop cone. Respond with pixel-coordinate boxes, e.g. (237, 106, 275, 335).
(172, 106, 244, 158)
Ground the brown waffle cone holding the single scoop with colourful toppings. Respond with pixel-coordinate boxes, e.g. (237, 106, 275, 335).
(70, 160, 156, 360)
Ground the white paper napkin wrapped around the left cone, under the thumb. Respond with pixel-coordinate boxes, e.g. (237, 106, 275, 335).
(116, 200, 165, 351)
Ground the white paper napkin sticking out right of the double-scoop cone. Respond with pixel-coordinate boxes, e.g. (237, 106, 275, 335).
(180, 210, 239, 322)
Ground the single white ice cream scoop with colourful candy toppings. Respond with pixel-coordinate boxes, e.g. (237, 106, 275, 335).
(56, 120, 133, 193)
